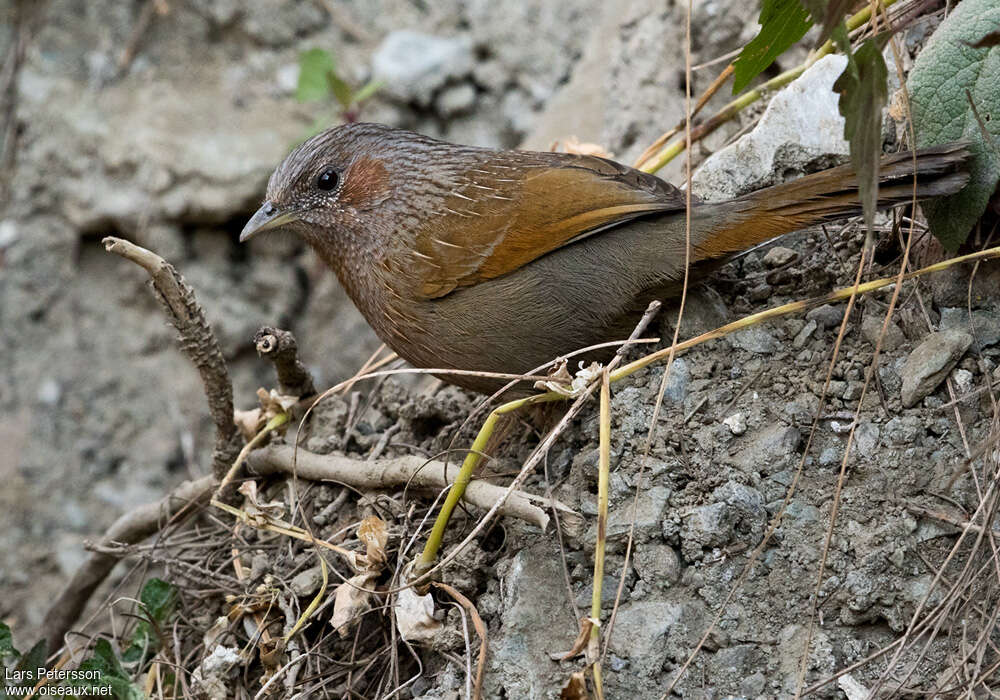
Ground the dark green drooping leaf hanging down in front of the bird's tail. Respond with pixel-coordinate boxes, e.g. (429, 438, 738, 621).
(833, 38, 889, 228)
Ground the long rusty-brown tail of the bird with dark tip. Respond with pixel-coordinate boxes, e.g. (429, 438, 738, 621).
(693, 143, 970, 260)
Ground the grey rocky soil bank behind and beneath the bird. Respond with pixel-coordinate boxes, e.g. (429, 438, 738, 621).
(0, 0, 1000, 698)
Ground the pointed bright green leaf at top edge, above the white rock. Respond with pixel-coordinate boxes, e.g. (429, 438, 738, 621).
(733, 0, 812, 94)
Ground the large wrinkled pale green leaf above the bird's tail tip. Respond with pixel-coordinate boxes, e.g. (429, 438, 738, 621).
(906, 0, 1000, 250)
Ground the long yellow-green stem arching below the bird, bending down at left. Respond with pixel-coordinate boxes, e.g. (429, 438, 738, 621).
(415, 246, 1000, 585)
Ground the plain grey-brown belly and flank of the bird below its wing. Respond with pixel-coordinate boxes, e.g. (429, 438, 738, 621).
(386, 220, 683, 391)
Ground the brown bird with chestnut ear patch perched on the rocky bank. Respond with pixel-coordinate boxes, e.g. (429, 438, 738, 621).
(240, 122, 969, 393)
